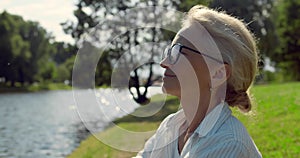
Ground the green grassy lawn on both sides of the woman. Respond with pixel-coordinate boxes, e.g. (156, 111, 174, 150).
(68, 83, 300, 158)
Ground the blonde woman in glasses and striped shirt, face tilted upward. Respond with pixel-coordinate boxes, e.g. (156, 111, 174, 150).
(137, 5, 261, 158)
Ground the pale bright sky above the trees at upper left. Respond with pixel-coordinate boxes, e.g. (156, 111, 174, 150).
(0, 0, 76, 43)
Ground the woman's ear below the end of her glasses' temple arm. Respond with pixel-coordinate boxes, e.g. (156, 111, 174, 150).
(212, 64, 231, 87)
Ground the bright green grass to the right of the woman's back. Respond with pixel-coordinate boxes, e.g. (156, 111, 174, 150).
(237, 83, 300, 158)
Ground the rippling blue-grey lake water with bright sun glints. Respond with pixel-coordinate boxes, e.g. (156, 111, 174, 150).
(0, 89, 163, 158)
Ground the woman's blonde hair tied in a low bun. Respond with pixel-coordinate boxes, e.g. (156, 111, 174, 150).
(183, 5, 258, 112)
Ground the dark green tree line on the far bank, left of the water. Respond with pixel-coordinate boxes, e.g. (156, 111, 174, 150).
(0, 11, 76, 87)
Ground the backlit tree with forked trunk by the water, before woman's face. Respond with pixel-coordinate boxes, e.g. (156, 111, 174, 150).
(62, 0, 207, 104)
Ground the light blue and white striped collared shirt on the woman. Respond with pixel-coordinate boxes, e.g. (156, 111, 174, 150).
(136, 103, 262, 158)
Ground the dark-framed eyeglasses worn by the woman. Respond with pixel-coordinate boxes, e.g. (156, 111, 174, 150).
(162, 43, 224, 65)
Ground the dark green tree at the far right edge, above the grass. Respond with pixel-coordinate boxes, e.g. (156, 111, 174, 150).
(271, 0, 300, 81)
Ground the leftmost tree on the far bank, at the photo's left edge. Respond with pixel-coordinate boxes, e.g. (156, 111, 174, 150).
(0, 11, 31, 86)
